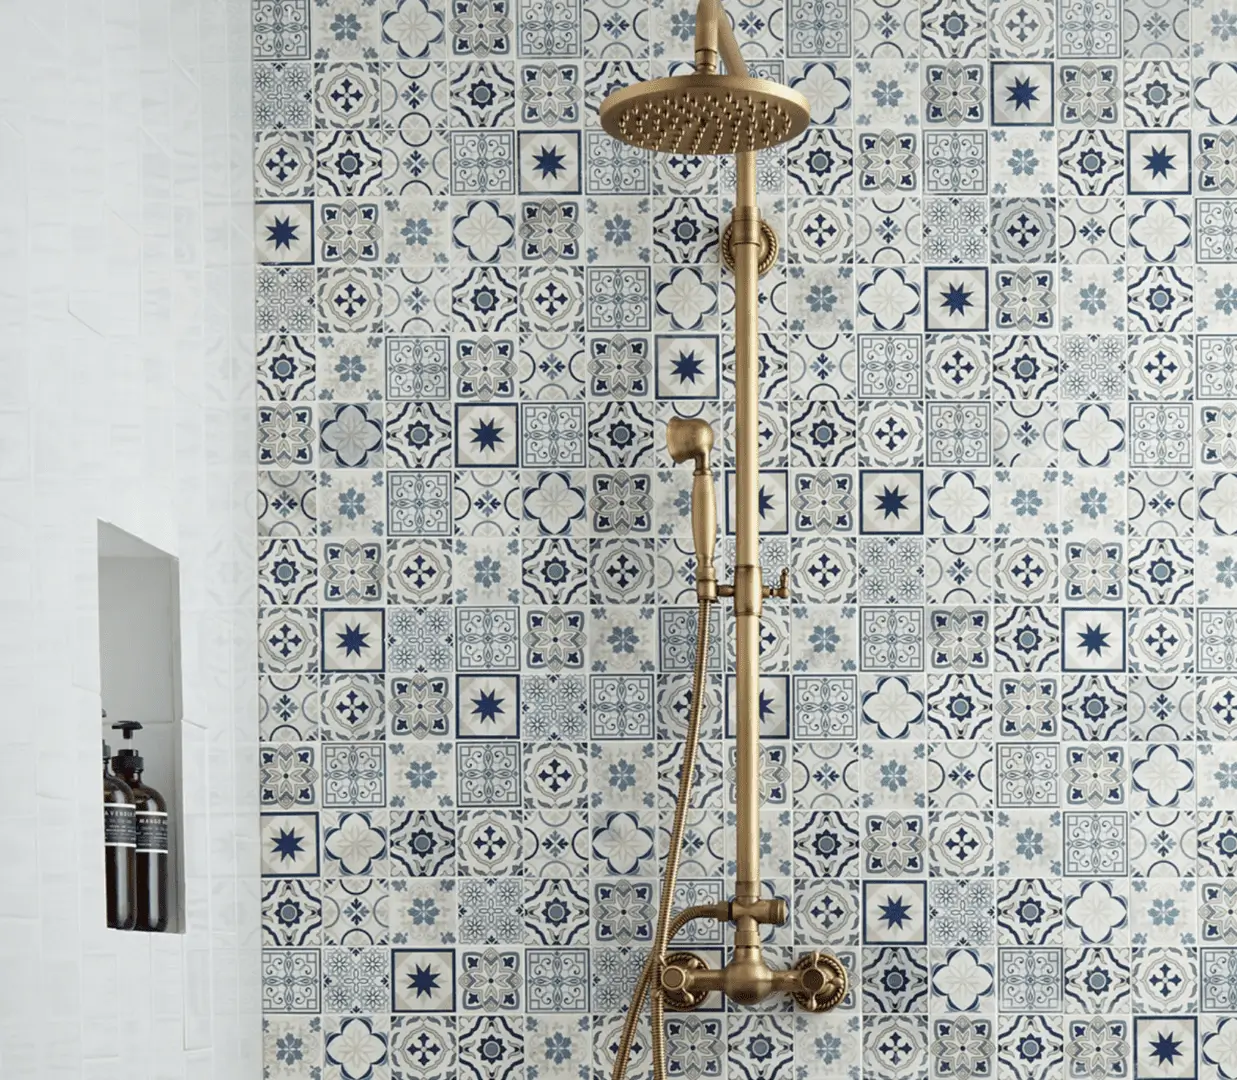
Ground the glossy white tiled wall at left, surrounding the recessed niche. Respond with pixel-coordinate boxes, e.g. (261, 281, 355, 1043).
(0, 0, 261, 1080)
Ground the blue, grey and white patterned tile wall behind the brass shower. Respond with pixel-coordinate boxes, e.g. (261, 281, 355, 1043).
(254, 0, 1237, 1080)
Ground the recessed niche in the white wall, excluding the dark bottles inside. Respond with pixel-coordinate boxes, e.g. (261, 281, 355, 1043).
(99, 521, 184, 933)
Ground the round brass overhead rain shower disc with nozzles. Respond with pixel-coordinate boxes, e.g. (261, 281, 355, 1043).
(601, 73, 810, 155)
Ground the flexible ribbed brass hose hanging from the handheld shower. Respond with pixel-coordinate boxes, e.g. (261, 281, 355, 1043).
(610, 600, 716, 1080)
